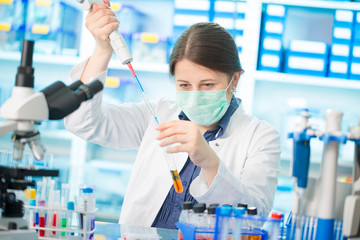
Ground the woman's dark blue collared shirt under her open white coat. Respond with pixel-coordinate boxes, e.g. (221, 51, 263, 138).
(151, 97, 241, 229)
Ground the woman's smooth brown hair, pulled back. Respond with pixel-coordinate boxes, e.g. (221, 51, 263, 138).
(169, 22, 243, 77)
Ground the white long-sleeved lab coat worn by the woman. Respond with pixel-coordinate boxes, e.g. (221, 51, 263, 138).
(65, 59, 280, 226)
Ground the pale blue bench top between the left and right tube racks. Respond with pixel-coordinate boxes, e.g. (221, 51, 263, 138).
(94, 222, 178, 240)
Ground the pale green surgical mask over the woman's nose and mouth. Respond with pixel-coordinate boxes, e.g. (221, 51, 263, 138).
(176, 79, 233, 126)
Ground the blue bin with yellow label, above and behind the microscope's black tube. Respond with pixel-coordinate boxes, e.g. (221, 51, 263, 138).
(25, 0, 82, 56)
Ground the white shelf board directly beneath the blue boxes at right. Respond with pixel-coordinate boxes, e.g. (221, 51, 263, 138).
(255, 71, 360, 90)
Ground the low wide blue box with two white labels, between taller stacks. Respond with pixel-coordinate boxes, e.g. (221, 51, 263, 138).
(285, 40, 329, 77)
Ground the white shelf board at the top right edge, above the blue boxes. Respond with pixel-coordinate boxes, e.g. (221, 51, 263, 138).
(263, 0, 360, 11)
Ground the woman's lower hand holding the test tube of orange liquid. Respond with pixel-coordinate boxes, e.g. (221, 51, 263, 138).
(156, 120, 220, 172)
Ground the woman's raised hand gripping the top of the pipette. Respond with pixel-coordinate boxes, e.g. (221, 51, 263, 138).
(85, 0, 119, 54)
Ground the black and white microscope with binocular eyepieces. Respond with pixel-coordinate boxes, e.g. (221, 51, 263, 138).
(0, 40, 103, 240)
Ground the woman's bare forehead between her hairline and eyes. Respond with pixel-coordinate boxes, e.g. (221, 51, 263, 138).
(174, 59, 228, 82)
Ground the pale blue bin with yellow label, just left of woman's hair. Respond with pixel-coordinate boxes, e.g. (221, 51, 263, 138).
(131, 33, 170, 63)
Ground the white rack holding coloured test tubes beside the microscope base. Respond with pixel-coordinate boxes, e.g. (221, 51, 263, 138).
(24, 205, 98, 240)
